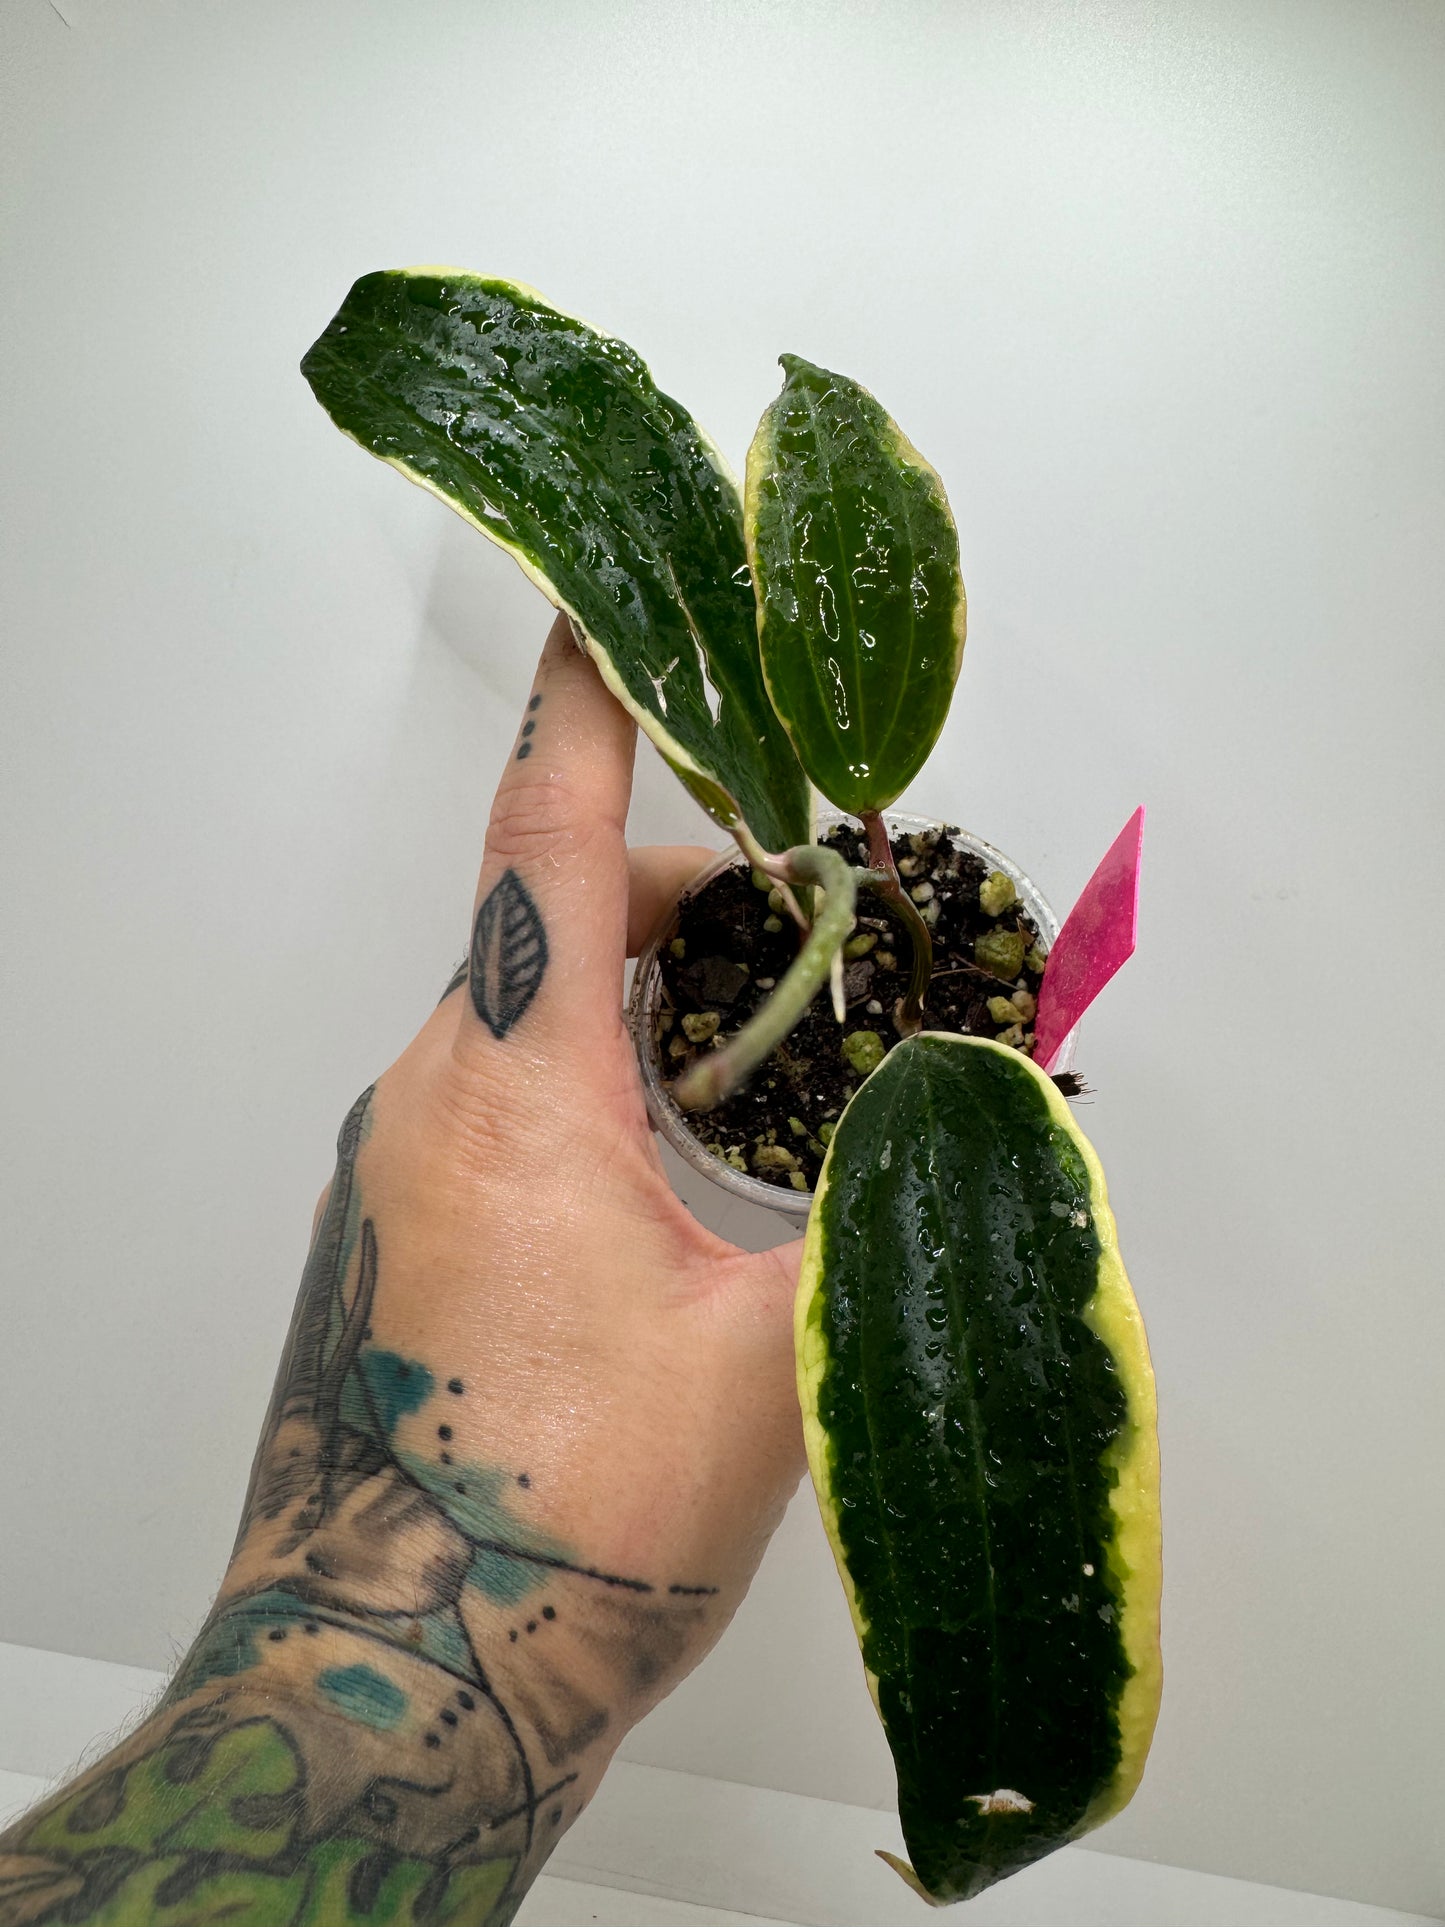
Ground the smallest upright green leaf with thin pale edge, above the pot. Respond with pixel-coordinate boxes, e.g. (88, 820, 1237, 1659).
(744, 355, 965, 815)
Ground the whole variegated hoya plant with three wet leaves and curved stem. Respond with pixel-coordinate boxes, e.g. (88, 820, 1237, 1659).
(302, 268, 1160, 1902)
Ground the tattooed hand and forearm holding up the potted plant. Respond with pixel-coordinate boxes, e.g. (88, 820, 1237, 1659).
(0, 619, 803, 1927)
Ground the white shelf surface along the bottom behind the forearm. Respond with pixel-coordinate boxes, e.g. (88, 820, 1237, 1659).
(0, 1642, 1433, 1927)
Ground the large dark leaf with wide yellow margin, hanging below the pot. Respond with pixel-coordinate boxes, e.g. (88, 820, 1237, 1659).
(796, 1033, 1160, 1900)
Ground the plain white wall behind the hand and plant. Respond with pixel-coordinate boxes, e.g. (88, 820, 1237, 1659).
(0, 0, 1445, 1914)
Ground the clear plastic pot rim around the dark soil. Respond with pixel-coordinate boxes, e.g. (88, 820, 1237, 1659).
(628, 809, 1079, 1220)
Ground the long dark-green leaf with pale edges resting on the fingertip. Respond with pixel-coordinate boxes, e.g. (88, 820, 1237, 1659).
(302, 268, 811, 850)
